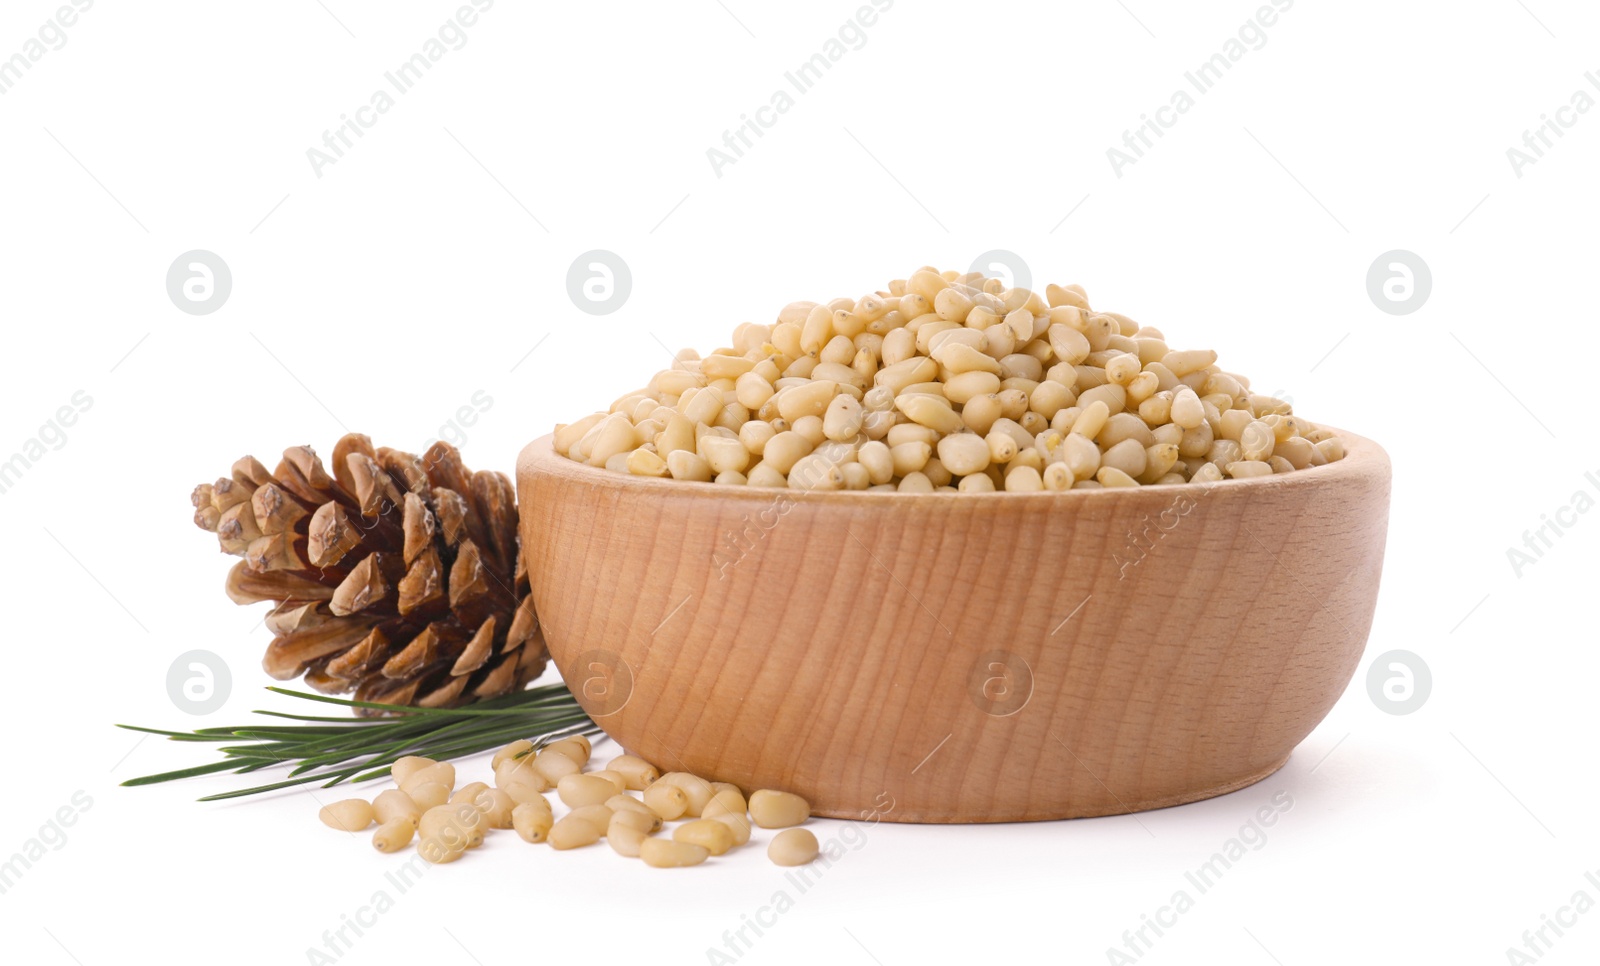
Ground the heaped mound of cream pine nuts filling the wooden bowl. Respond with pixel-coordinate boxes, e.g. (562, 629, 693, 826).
(554, 267, 1344, 493)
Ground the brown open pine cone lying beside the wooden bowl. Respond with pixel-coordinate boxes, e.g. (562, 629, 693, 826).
(192, 433, 547, 707)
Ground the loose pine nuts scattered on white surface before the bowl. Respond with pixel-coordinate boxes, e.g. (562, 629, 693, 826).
(318, 734, 819, 868)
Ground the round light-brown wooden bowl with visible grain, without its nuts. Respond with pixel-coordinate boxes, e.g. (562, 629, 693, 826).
(517, 432, 1389, 822)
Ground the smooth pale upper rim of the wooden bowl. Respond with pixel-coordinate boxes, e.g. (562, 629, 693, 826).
(517, 424, 1389, 505)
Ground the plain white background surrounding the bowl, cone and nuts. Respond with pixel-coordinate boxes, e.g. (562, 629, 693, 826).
(0, 0, 1600, 966)
